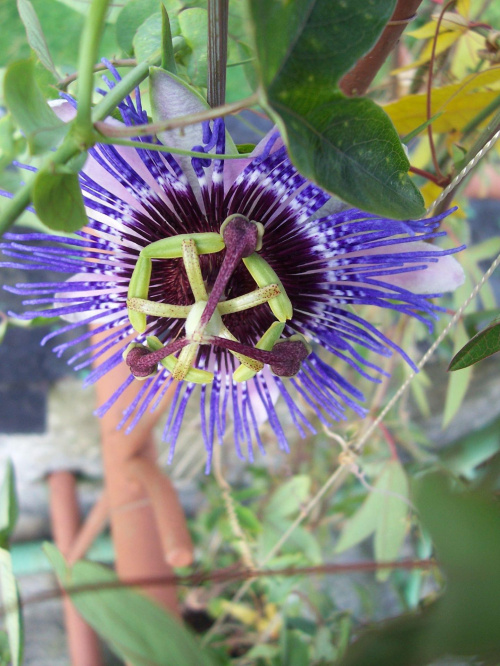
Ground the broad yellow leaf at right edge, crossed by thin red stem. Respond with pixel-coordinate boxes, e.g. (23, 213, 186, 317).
(384, 67, 500, 135)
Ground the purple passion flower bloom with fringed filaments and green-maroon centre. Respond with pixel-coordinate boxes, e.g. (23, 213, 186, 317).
(2, 70, 463, 469)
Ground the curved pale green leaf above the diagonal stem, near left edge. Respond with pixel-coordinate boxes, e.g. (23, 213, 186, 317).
(4, 60, 68, 155)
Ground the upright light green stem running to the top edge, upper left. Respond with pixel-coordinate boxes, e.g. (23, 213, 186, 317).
(75, 0, 109, 132)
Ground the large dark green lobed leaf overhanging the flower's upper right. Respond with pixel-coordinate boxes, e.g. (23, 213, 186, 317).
(249, 0, 424, 219)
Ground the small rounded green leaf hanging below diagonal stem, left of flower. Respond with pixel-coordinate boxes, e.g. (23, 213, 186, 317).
(33, 170, 88, 233)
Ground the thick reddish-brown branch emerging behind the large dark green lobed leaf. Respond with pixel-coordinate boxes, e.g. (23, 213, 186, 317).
(340, 0, 422, 97)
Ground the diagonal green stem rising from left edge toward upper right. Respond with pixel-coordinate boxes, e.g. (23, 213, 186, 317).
(0, 52, 160, 234)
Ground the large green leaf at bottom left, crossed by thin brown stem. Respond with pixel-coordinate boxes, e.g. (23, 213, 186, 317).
(44, 543, 219, 666)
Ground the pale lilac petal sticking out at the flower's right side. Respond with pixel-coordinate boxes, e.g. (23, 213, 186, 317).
(364, 241, 465, 294)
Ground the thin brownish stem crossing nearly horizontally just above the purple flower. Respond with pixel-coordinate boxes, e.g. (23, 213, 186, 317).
(94, 92, 260, 138)
